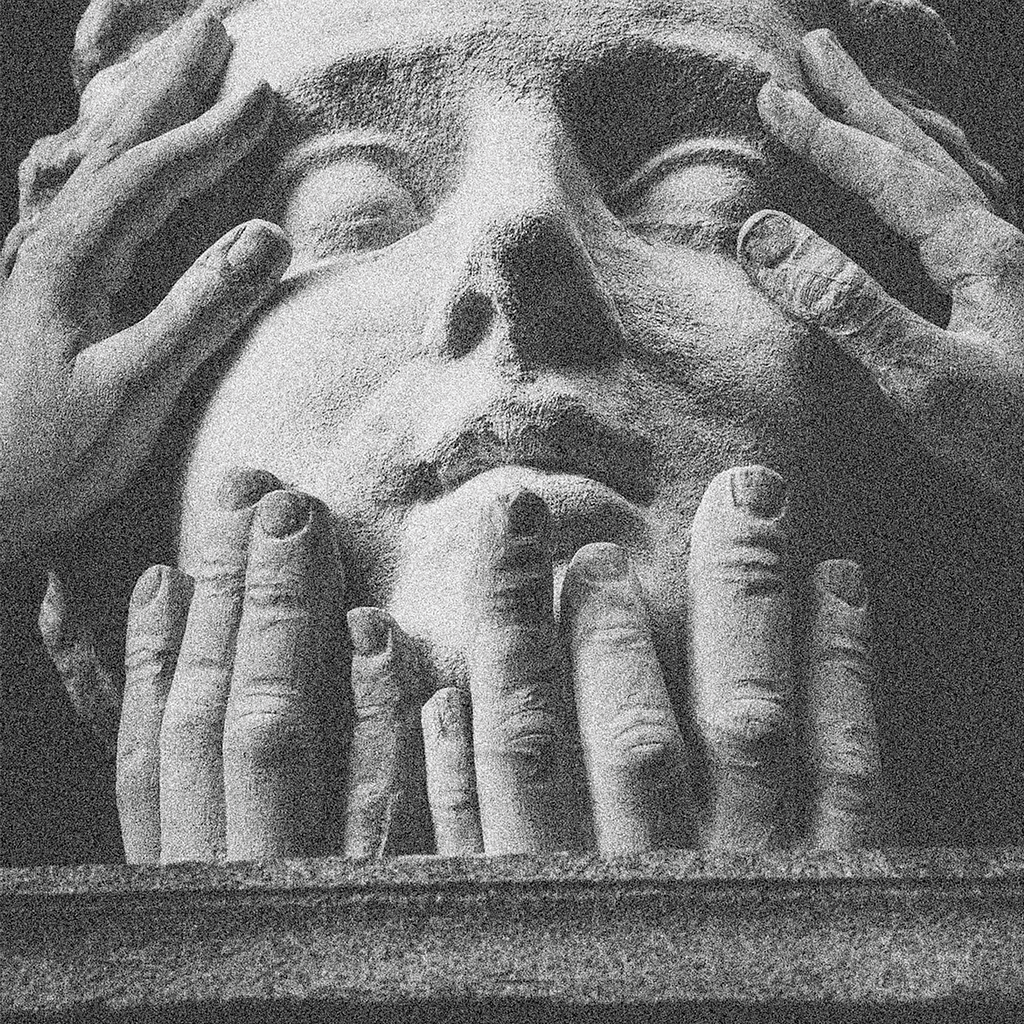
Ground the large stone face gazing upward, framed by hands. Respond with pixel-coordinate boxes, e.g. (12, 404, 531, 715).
(172, 0, 884, 688)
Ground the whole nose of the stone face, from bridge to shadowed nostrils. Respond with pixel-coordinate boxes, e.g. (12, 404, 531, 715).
(434, 96, 621, 365)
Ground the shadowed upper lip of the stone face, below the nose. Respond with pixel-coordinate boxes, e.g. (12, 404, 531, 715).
(399, 396, 656, 505)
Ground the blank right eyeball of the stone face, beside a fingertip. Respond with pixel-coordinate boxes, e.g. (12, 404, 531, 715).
(611, 152, 763, 253)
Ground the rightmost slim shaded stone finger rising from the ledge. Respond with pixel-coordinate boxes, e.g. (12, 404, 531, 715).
(807, 560, 882, 849)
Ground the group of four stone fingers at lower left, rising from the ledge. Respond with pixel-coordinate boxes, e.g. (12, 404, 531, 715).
(117, 470, 422, 863)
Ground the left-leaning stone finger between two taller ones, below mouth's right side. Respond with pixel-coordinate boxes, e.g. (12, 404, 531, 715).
(561, 544, 688, 854)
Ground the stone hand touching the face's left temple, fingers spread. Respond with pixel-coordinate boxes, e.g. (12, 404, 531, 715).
(0, 16, 290, 552)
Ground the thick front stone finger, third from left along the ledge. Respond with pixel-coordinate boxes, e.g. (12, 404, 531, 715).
(223, 490, 344, 860)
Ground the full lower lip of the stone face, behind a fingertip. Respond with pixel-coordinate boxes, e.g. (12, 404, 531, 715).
(446, 466, 650, 562)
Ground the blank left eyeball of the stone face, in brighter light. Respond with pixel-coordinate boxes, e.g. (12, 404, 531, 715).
(280, 156, 425, 258)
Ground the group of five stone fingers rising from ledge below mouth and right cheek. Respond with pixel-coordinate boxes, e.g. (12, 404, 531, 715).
(423, 467, 880, 854)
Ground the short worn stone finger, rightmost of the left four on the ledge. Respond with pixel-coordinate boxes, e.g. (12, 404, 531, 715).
(344, 607, 419, 857)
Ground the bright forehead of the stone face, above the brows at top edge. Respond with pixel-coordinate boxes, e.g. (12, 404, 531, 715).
(220, 0, 834, 89)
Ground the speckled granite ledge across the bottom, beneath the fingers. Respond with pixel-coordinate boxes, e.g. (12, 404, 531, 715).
(0, 849, 1024, 1024)
